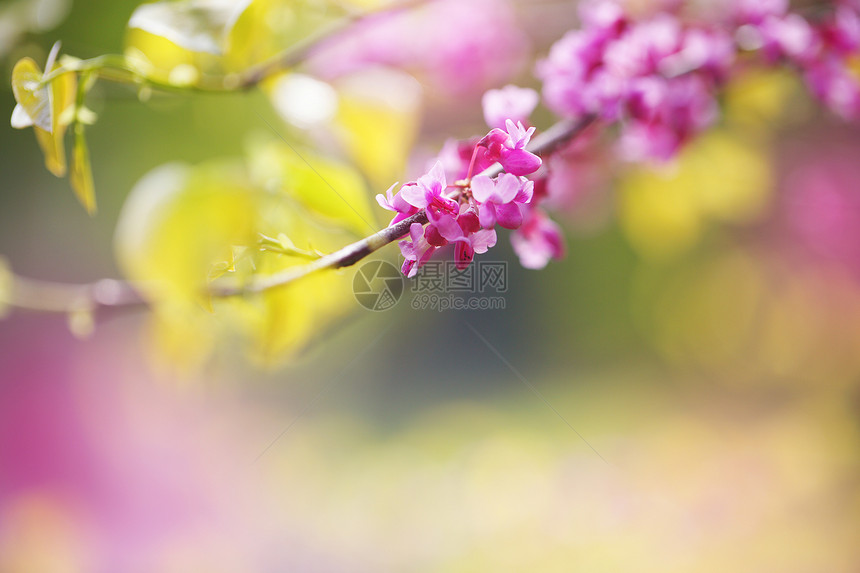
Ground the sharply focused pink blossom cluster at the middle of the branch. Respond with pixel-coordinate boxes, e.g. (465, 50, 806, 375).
(376, 115, 561, 277)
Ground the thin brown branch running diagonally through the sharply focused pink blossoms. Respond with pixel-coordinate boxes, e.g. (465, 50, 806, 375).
(0, 115, 596, 313)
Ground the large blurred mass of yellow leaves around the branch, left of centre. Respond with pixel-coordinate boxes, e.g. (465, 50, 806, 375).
(116, 143, 370, 368)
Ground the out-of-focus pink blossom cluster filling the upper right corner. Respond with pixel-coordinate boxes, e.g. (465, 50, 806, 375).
(538, 0, 860, 160)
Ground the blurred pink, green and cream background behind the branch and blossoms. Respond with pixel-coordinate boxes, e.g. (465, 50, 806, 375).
(0, 0, 860, 573)
